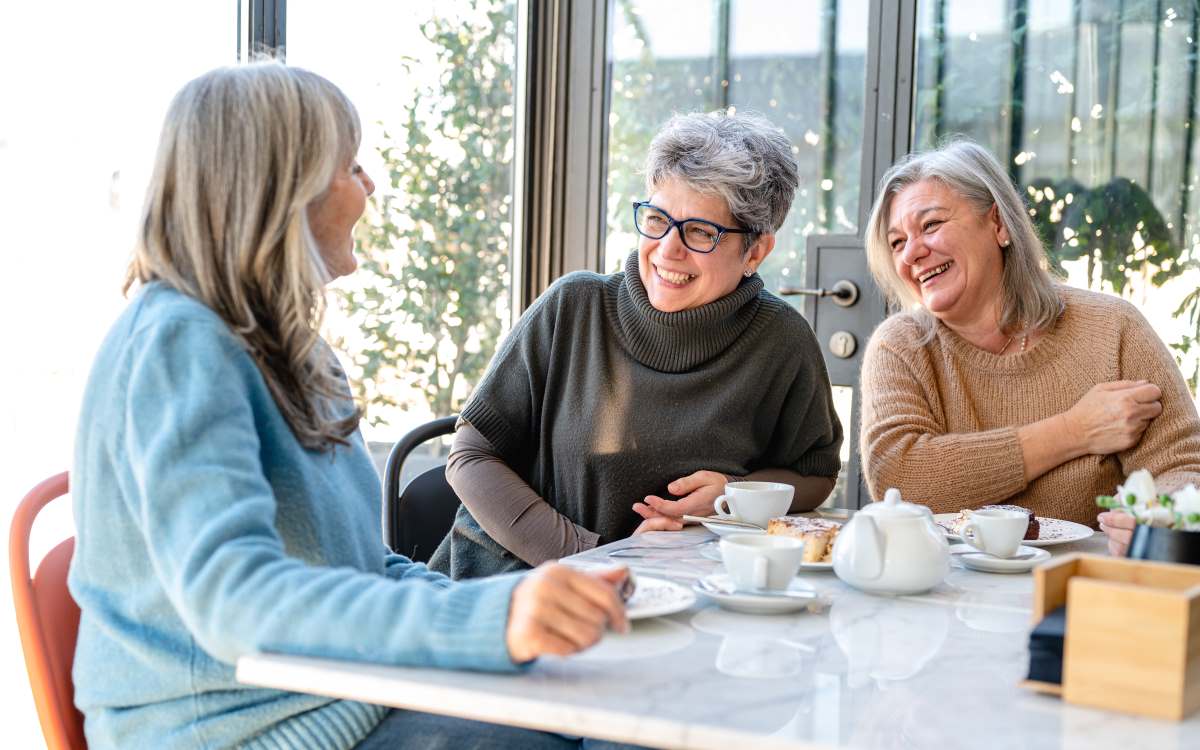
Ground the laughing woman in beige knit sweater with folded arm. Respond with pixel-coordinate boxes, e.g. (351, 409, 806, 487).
(860, 140, 1200, 553)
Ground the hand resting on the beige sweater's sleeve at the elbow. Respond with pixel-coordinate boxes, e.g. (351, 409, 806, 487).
(1063, 380, 1163, 456)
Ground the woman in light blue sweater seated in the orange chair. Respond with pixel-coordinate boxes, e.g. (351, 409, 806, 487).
(70, 62, 643, 750)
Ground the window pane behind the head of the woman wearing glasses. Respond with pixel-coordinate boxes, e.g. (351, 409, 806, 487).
(605, 0, 868, 289)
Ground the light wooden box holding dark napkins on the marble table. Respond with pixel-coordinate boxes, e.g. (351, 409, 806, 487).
(1033, 554, 1200, 719)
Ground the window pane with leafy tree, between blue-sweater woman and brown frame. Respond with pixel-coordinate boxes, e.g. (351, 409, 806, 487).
(287, 0, 516, 456)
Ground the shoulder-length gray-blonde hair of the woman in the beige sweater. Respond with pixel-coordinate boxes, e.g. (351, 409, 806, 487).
(866, 138, 1062, 337)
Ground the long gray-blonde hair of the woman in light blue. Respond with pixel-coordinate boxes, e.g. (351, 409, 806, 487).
(125, 61, 361, 450)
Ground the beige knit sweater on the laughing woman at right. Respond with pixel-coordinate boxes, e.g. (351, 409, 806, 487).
(860, 287, 1200, 527)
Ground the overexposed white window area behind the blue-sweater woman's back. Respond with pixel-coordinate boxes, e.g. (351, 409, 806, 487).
(0, 0, 238, 748)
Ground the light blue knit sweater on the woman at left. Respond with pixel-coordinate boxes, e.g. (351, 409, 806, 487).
(70, 283, 518, 750)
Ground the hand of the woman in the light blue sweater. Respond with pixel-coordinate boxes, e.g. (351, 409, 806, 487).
(504, 563, 629, 662)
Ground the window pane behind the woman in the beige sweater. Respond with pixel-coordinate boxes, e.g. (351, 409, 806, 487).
(914, 0, 1200, 390)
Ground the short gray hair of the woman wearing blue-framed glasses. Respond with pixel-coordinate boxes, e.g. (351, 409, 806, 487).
(646, 110, 800, 247)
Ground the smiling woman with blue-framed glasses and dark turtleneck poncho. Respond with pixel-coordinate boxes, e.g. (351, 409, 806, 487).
(431, 113, 841, 577)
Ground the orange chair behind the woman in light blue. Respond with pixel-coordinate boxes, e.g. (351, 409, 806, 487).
(8, 472, 88, 750)
